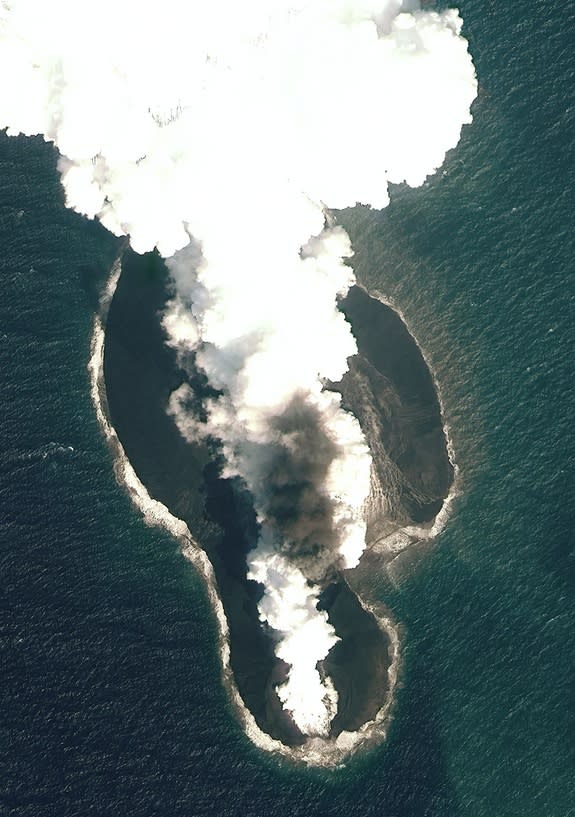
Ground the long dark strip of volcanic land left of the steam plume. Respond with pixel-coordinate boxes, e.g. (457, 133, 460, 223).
(104, 252, 303, 745)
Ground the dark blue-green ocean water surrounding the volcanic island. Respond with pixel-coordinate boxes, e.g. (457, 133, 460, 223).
(0, 0, 575, 817)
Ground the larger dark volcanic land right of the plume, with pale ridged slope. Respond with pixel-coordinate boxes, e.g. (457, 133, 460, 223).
(333, 286, 453, 525)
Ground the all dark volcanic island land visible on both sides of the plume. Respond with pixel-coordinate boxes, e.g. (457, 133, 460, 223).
(104, 251, 453, 745)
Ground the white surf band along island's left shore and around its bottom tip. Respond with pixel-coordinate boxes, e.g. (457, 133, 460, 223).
(88, 255, 400, 767)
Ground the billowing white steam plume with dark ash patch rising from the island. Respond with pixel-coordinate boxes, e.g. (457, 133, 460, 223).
(0, 0, 476, 734)
